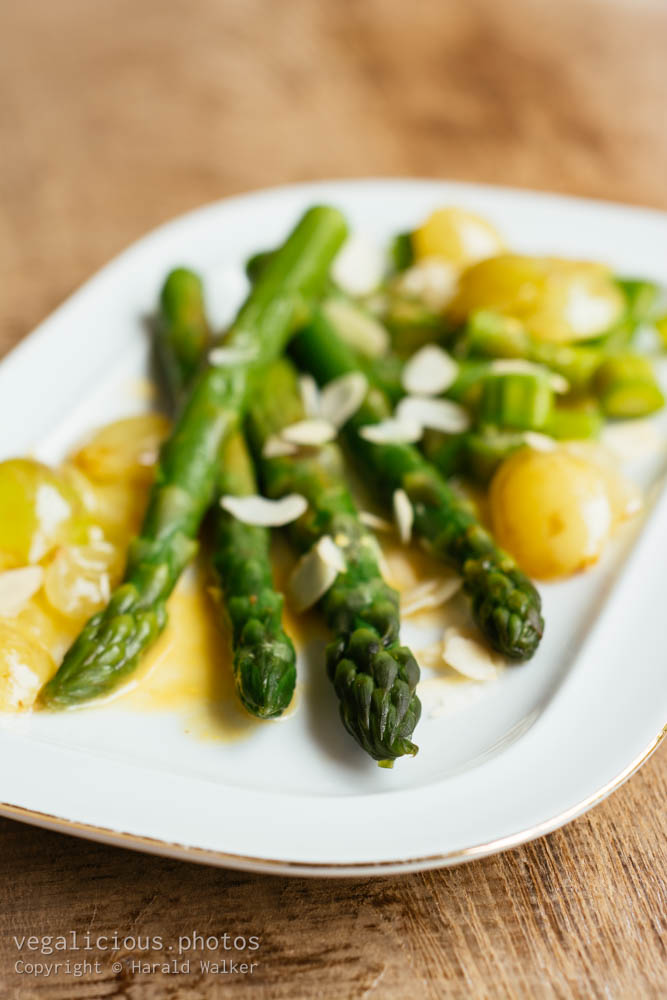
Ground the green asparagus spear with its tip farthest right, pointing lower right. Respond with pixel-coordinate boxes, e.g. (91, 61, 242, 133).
(292, 311, 544, 660)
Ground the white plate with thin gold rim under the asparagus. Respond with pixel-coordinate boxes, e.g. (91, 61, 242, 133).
(0, 180, 667, 875)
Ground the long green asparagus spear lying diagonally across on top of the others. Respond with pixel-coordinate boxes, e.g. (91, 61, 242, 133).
(42, 207, 346, 708)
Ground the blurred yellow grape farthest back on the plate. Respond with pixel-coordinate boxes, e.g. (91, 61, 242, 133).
(412, 208, 503, 267)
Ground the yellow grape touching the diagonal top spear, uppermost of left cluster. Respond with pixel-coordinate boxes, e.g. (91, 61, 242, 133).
(72, 413, 169, 483)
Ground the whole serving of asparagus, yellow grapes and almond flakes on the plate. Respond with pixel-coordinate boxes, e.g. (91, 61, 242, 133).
(0, 199, 665, 766)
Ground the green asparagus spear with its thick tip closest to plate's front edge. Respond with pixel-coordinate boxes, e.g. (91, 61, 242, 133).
(249, 359, 421, 765)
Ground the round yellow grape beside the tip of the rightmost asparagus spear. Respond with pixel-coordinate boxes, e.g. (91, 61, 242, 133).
(490, 448, 614, 580)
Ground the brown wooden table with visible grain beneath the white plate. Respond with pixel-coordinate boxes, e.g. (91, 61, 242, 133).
(0, 0, 667, 1000)
